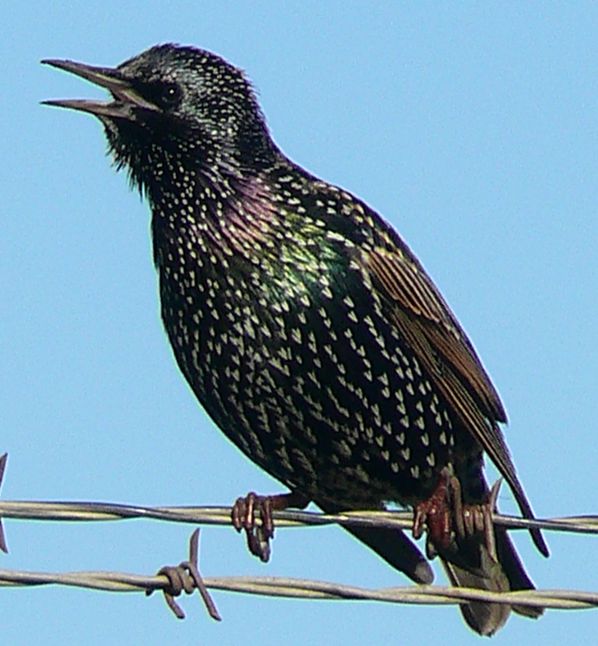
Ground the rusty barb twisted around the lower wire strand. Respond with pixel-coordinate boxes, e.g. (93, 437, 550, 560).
(145, 529, 221, 621)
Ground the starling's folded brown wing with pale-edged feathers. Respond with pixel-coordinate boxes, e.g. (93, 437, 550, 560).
(363, 239, 547, 553)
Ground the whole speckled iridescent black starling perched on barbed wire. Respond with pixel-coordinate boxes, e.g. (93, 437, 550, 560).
(43, 44, 548, 635)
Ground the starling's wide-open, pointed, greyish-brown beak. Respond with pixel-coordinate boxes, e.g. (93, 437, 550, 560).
(42, 59, 158, 120)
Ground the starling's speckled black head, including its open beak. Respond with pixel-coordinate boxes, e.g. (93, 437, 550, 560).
(42, 44, 274, 188)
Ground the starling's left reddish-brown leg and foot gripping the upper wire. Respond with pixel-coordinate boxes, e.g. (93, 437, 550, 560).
(231, 491, 309, 563)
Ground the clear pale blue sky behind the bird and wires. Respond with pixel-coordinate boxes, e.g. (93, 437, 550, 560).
(0, 1, 598, 646)
